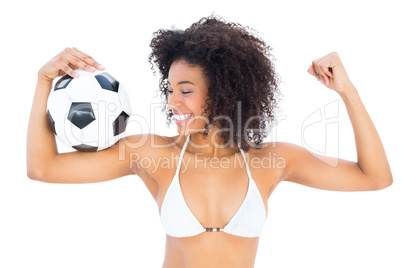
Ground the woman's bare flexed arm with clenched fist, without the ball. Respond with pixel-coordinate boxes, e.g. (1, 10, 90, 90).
(280, 53, 393, 191)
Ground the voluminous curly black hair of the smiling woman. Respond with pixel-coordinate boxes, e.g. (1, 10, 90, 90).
(148, 15, 280, 152)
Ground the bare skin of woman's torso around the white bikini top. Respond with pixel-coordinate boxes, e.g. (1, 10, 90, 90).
(134, 136, 284, 268)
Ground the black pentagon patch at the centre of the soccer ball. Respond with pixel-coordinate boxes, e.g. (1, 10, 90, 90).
(67, 102, 96, 129)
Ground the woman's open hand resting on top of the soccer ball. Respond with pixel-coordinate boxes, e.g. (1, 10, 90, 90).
(38, 47, 105, 81)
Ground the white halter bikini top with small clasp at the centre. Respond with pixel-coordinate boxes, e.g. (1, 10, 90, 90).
(161, 135, 266, 237)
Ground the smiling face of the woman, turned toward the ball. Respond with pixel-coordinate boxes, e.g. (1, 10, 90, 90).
(168, 60, 208, 135)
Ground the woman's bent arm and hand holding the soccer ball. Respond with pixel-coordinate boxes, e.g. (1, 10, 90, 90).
(27, 48, 139, 183)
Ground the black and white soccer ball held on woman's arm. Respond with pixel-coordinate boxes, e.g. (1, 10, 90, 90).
(47, 69, 131, 152)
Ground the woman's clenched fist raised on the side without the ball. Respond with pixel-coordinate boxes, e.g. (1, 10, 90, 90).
(308, 52, 356, 94)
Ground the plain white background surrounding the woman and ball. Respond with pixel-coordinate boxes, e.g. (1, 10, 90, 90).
(0, 0, 402, 268)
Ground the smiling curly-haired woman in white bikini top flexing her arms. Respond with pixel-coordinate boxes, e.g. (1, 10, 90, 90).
(27, 17, 392, 268)
